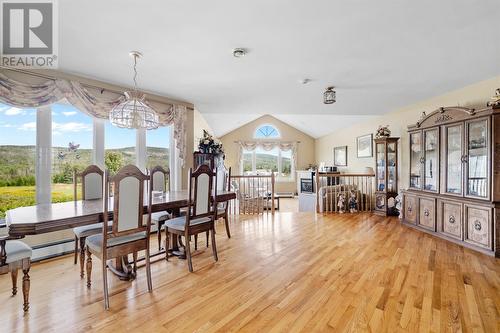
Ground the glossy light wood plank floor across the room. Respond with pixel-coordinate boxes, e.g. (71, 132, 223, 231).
(0, 213, 500, 333)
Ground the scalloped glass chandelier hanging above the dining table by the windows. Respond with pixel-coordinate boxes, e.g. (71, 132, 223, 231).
(109, 51, 159, 130)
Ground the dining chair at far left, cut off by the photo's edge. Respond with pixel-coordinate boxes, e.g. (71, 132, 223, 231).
(0, 236, 33, 312)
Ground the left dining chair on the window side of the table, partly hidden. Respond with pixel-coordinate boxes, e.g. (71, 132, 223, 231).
(73, 165, 111, 279)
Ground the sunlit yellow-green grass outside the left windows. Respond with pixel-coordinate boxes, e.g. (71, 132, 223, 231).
(0, 184, 81, 218)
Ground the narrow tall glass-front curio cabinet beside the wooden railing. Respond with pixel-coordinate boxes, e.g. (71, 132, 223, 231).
(374, 137, 399, 216)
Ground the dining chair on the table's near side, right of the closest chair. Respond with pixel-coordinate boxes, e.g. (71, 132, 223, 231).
(165, 164, 218, 272)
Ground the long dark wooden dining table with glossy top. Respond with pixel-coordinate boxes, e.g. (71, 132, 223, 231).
(5, 190, 236, 280)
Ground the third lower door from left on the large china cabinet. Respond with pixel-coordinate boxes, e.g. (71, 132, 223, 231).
(437, 200, 463, 240)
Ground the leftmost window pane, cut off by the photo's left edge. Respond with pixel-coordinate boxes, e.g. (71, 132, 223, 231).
(0, 103, 36, 219)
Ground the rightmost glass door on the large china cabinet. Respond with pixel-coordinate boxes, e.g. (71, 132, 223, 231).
(465, 119, 489, 198)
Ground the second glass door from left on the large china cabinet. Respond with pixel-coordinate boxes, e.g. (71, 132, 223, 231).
(424, 128, 439, 192)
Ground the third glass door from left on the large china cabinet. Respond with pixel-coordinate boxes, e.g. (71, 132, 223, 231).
(444, 124, 464, 195)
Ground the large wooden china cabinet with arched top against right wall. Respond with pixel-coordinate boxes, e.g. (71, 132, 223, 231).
(402, 104, 500, 257)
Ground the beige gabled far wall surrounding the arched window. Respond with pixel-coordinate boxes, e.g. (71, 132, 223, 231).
(220, 115, 314, 192)
